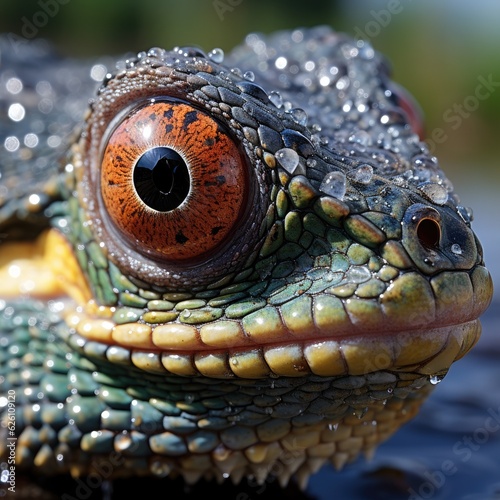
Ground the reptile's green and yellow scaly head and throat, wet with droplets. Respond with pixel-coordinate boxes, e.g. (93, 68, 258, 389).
(0, 28, 492, 484)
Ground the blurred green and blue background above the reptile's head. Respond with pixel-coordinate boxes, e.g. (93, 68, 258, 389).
(0, 0, 500, 289)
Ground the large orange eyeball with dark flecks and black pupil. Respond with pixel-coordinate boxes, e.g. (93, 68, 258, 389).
(101, 101, 248, 261)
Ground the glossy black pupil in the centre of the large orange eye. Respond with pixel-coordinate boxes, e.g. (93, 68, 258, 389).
(134, 147, 190, 212)
